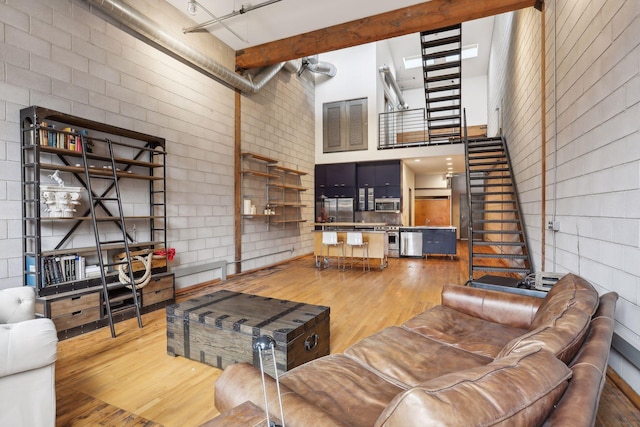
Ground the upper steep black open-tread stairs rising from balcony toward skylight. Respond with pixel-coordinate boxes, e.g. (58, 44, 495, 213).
(420, 24, 462, 144)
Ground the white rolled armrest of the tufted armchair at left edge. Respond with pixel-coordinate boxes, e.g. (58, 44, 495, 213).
(0, 318, 58, 377)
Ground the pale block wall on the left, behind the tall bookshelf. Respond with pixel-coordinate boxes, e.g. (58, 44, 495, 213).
(0, 0, 313, 288)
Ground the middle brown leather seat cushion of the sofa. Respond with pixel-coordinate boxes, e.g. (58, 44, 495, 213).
(344, 326, 493, 389)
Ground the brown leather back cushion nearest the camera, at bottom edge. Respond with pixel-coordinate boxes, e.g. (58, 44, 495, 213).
(375, 349, 571, 427)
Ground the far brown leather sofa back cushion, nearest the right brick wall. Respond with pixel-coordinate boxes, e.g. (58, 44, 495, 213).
(496, 274, 600, 363)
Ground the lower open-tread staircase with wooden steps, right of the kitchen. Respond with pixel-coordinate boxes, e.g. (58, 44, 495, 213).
(465, 137, 532, 281)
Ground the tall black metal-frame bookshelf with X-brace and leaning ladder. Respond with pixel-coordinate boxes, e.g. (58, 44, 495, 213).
(20, 106, 173, 336)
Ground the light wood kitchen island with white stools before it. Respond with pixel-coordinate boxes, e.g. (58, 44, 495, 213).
(313, 231, 389, 270)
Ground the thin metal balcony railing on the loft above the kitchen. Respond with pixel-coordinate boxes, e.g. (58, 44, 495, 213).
(378, 108, 462, 150)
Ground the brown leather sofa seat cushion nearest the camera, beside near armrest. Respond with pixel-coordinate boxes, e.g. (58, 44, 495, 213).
(280, 354, 404, 427)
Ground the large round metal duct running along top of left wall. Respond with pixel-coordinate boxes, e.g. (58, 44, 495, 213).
(85, 0, 302, 93)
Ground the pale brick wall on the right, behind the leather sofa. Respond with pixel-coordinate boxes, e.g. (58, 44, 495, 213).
(489, 0, 640, 392)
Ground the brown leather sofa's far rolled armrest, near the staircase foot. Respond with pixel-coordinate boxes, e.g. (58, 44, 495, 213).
(442, 285, 544, 329)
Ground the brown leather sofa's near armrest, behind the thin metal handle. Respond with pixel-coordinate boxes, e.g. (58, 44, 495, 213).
(214, 363, 346, 427)
